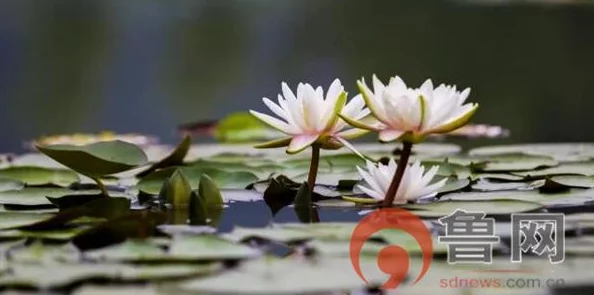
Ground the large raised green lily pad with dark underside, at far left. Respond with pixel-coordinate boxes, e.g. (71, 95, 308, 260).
(37, 140, 148, 178)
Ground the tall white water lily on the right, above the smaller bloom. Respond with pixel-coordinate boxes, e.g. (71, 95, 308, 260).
(341, 75, 478, 143)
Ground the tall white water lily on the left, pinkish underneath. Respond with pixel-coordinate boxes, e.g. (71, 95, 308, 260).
(250, 79, 370, 154)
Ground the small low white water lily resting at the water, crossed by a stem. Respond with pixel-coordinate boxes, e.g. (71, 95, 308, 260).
(357, 159, 447, 204)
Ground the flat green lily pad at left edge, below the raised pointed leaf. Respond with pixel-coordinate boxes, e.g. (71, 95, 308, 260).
(0, 166, 80, 187)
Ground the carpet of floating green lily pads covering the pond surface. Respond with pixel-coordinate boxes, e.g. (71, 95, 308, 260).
(0, 138, 594, 294)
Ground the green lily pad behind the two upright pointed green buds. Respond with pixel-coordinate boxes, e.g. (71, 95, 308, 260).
(136, 166, 258, 195)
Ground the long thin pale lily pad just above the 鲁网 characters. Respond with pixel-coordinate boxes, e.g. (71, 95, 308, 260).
(403, 200, 543, 217)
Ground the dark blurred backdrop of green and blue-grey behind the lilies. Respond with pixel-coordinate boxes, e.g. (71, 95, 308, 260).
(0, 0, 594, 152)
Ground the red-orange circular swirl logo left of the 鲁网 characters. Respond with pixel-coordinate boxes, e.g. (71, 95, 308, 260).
(349, 208, 433, 289)
